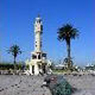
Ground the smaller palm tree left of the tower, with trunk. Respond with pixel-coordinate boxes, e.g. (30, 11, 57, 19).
(8, 45, 22, 67)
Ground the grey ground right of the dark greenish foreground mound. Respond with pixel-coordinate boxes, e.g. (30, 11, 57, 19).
(65, 75, 95, 95)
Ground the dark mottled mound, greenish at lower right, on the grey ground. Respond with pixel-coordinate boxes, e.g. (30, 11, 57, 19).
(44, 75, 72, 95)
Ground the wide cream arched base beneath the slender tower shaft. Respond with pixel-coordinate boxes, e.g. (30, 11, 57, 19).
(28, 52, 48, 75)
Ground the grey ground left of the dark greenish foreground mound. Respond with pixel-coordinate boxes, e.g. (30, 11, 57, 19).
(0, 75, 51, 95)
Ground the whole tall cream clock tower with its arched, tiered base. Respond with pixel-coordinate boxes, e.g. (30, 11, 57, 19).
(26, 16, 48, 75)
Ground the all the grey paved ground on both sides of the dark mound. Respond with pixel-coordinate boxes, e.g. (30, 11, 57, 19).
(0, 75, 95, 95)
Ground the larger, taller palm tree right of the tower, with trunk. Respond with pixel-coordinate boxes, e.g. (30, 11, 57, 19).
(57, 24, 79, 68)
